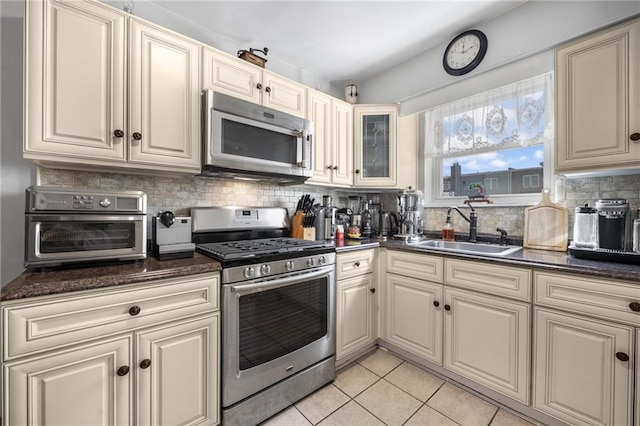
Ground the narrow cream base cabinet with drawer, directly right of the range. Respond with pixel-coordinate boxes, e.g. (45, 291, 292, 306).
(336, 249, 378, 366)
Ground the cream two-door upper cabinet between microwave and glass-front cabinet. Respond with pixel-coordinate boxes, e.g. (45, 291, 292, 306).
(307, 89, 353, 186)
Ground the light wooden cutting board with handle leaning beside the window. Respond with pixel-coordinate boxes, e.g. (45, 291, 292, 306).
(523, 188, 569, 251)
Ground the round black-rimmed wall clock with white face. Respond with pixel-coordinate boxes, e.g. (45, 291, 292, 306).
(442, 30, 488, 75)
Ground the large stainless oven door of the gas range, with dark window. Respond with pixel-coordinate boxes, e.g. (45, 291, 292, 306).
(222, 265, 335, 407)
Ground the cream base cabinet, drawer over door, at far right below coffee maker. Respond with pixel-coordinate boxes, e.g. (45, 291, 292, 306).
(533, 271, 640, 425)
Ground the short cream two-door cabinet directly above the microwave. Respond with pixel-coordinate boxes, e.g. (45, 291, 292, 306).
(202, 46, 307, 117)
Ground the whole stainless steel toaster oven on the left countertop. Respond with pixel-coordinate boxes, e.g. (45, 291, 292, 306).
(24, 186, 147, 267)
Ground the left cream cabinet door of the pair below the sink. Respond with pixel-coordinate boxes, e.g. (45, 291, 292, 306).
(385, 274, 443, 364)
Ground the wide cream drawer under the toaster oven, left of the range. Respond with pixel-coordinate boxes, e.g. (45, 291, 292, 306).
(2, 273, 220, 361)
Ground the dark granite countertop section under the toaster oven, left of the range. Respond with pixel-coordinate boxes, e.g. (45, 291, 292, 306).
(0, 253, 221, 302)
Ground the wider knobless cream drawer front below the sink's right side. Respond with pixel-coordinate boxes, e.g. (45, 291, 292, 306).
(444, 259, 531, 302)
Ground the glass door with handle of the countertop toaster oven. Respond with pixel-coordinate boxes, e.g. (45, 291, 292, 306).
(25, 214, 147, 267)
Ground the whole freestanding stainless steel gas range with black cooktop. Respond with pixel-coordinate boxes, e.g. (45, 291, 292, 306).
(191, 207, 336, 426)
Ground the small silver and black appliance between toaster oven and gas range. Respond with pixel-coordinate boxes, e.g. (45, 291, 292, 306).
(151, 211, 196, 260)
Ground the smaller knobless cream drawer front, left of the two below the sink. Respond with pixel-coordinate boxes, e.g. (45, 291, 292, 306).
(385, 250, 443, 283)
